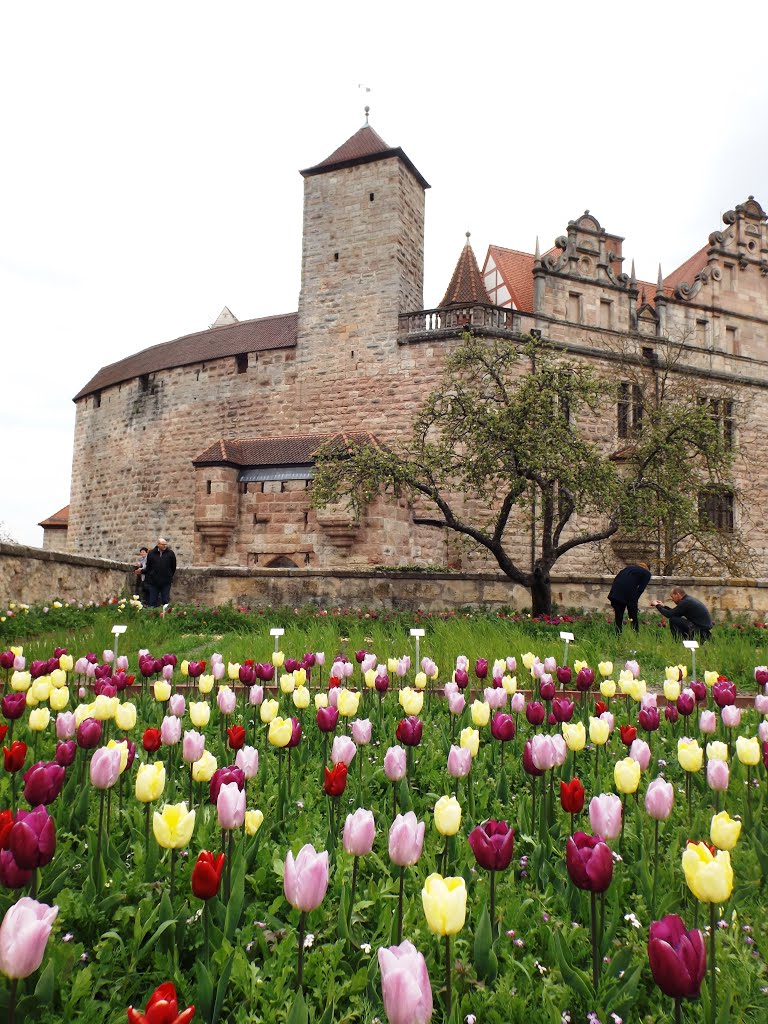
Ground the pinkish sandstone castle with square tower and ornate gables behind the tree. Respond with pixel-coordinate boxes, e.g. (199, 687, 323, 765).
(41, 122, 768, 575)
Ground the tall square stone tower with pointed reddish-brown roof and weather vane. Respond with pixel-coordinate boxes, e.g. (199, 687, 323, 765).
(296, 117, 429, 384)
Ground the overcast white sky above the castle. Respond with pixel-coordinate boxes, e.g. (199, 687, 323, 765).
(0, 0, 768, 556)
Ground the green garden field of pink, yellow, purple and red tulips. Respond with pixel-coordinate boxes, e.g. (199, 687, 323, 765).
(0, 602, 768, 1024)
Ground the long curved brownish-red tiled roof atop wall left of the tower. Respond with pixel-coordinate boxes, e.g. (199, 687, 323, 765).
(74, 313, 298, 401)
